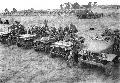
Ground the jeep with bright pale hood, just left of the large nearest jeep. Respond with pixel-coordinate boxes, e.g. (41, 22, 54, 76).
(50, 41, 73, 60)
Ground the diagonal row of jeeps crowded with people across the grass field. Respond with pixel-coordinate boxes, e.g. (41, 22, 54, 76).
(0, 20, 120, 71)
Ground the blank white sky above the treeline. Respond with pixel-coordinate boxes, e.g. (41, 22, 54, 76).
(0, 0, 120, 11)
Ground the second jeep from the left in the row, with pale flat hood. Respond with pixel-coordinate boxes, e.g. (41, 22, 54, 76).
(17, 34, 36, 49)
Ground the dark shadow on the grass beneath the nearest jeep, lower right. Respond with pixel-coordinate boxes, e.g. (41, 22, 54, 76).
(80, 63, 120, 81)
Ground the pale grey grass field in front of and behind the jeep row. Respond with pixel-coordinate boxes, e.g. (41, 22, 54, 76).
(0, 12, 120, 83)
